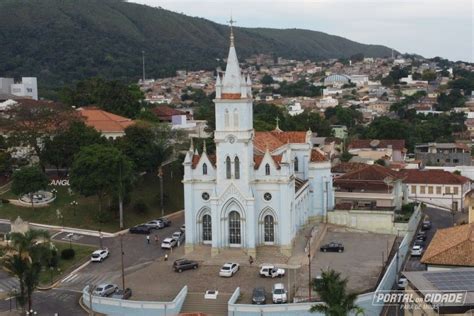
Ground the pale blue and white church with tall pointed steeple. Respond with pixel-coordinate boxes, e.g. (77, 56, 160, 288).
(183, 27, 334, 257)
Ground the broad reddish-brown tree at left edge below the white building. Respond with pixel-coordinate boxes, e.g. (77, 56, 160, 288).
(0, 101, 79, 166)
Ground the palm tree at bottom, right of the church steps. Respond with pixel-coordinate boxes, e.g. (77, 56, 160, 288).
(310, 270, 364, 316)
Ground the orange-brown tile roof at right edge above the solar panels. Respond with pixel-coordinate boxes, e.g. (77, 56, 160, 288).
(421, 224, 474, 267)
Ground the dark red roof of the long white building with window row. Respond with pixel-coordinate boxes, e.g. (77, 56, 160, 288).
(400, 169, 471, 184)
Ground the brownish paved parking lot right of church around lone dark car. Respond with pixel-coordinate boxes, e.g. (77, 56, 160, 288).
(298, 227, 395, 297)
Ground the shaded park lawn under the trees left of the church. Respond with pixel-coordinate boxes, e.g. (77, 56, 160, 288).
(0, 161, 184, 232)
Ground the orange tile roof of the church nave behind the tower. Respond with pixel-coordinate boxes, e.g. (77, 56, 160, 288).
(253, 131, 306, 152)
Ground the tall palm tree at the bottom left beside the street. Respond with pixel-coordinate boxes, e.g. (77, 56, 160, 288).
(2, 230, 51, 310)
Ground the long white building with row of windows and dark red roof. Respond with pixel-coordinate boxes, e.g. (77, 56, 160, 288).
(401, 169, 471, 211)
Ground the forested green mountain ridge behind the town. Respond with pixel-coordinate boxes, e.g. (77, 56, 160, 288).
(0, 0, 391, 93)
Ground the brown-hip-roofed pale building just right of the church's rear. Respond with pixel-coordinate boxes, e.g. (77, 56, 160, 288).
(334, 165, 403, 210)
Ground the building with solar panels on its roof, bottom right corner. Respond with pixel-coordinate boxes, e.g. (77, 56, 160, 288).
(403, 269, 474, 316)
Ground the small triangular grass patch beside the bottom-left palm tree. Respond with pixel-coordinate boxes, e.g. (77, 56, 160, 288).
(39, 242, 97, 286)
